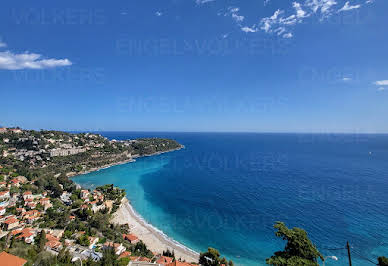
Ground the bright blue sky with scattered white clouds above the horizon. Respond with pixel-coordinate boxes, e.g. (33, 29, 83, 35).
(0, 0, 388, 133)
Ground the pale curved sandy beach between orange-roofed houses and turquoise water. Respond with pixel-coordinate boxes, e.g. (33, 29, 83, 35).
(112, 198, 199, 262)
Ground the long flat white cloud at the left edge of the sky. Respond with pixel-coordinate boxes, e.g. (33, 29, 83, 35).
(0, 51, 72, 70)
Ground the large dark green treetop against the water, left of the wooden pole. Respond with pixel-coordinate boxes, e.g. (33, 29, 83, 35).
(266, 222, 324, 266)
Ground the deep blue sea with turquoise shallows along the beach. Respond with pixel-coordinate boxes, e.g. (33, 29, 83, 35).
(75, 132, 388, 265)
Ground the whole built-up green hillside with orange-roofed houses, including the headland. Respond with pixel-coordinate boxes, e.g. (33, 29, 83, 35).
(0, 128, 197, 266)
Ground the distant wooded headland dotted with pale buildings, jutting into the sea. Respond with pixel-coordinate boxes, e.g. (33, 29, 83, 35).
(0, 128, 183, 181)
